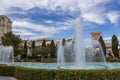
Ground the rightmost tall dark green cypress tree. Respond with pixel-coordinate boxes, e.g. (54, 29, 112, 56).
(112, 35, 119, 58)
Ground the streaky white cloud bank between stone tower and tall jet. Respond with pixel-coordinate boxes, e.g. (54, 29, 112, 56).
(13, 19, 72, 39)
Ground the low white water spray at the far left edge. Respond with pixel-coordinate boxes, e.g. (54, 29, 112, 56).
(0, 46, 14, 63)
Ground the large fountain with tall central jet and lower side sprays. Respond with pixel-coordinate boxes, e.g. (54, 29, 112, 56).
(57, 18, 106, 69)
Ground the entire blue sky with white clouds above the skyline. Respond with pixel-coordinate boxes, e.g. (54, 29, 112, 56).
(0, 0, 120, 42)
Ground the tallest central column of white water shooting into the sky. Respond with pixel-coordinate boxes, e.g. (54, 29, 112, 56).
(74, 18, 86, 67)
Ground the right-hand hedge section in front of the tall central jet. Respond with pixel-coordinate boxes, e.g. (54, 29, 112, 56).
(57, 70, 120, 80)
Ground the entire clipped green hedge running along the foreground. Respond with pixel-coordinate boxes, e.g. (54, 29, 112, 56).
(0, 65, 120, 80)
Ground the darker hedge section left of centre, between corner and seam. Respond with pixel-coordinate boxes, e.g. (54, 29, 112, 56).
(15, 67, 55, 80)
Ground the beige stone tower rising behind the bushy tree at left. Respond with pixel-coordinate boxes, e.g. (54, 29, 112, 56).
(0, 15, 12, 44)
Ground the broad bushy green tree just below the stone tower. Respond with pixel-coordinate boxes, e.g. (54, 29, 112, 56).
(1, 32, 21, 56)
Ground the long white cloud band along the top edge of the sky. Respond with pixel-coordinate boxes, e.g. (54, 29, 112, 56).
(1, 0, 109, 11)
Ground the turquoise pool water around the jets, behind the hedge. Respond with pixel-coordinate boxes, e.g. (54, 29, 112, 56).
(5, 62, 120, 69)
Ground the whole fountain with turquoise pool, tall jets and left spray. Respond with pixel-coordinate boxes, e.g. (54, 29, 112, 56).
(3, 19, 120, 70)
